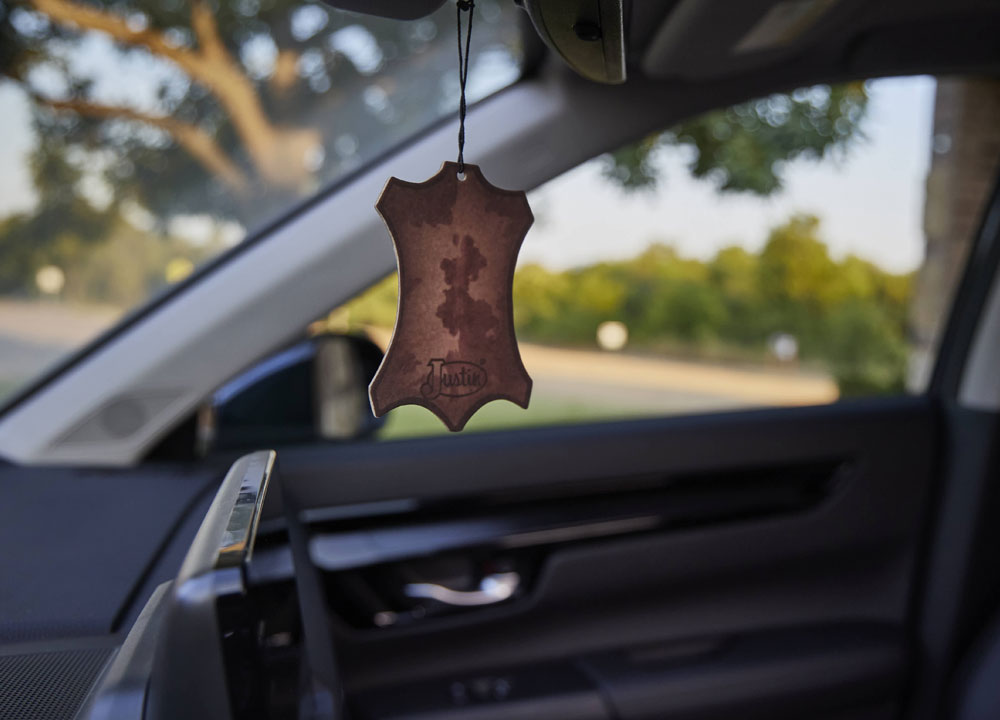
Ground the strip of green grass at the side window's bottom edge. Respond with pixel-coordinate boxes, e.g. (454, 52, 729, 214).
(379, 396, 636, 440)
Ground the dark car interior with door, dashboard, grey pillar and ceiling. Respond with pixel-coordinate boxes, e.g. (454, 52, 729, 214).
(0, 0, 1000, 720)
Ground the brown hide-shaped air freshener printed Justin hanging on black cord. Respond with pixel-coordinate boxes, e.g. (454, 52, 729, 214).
(368, 162, 534, 431)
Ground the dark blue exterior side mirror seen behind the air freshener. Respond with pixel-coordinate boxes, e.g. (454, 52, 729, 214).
(208, 334, 384, 450)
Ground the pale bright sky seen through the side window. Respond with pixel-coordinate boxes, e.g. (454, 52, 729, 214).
(520, 77, 934, 272)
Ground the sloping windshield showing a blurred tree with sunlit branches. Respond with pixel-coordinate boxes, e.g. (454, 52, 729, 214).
(0, 0, 521, 400)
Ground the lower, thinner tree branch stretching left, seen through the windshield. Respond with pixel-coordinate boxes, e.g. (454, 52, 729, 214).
(34, 95, 250, 195)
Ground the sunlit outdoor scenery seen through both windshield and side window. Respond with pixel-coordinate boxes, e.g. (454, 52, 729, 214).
(0, 0, 982, 437)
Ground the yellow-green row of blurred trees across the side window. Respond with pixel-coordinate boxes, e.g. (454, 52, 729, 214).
(346, 215, 913, 395)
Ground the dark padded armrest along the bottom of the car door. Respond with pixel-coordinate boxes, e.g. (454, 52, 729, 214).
(355, 623, 903, 720)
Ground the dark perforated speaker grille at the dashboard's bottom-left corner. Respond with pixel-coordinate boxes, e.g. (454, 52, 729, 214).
(0, 648, 111, 720)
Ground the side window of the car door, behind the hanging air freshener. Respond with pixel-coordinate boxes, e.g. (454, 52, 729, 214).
(327, 77, 1000, 439)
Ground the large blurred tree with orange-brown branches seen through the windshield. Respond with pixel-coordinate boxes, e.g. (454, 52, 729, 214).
(0, 0, 517, 289)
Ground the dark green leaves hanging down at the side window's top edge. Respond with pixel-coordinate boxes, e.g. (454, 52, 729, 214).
(604, 83, 868, 195)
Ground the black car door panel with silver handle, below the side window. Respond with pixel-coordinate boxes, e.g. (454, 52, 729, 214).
(262, 398, 938, 718)
